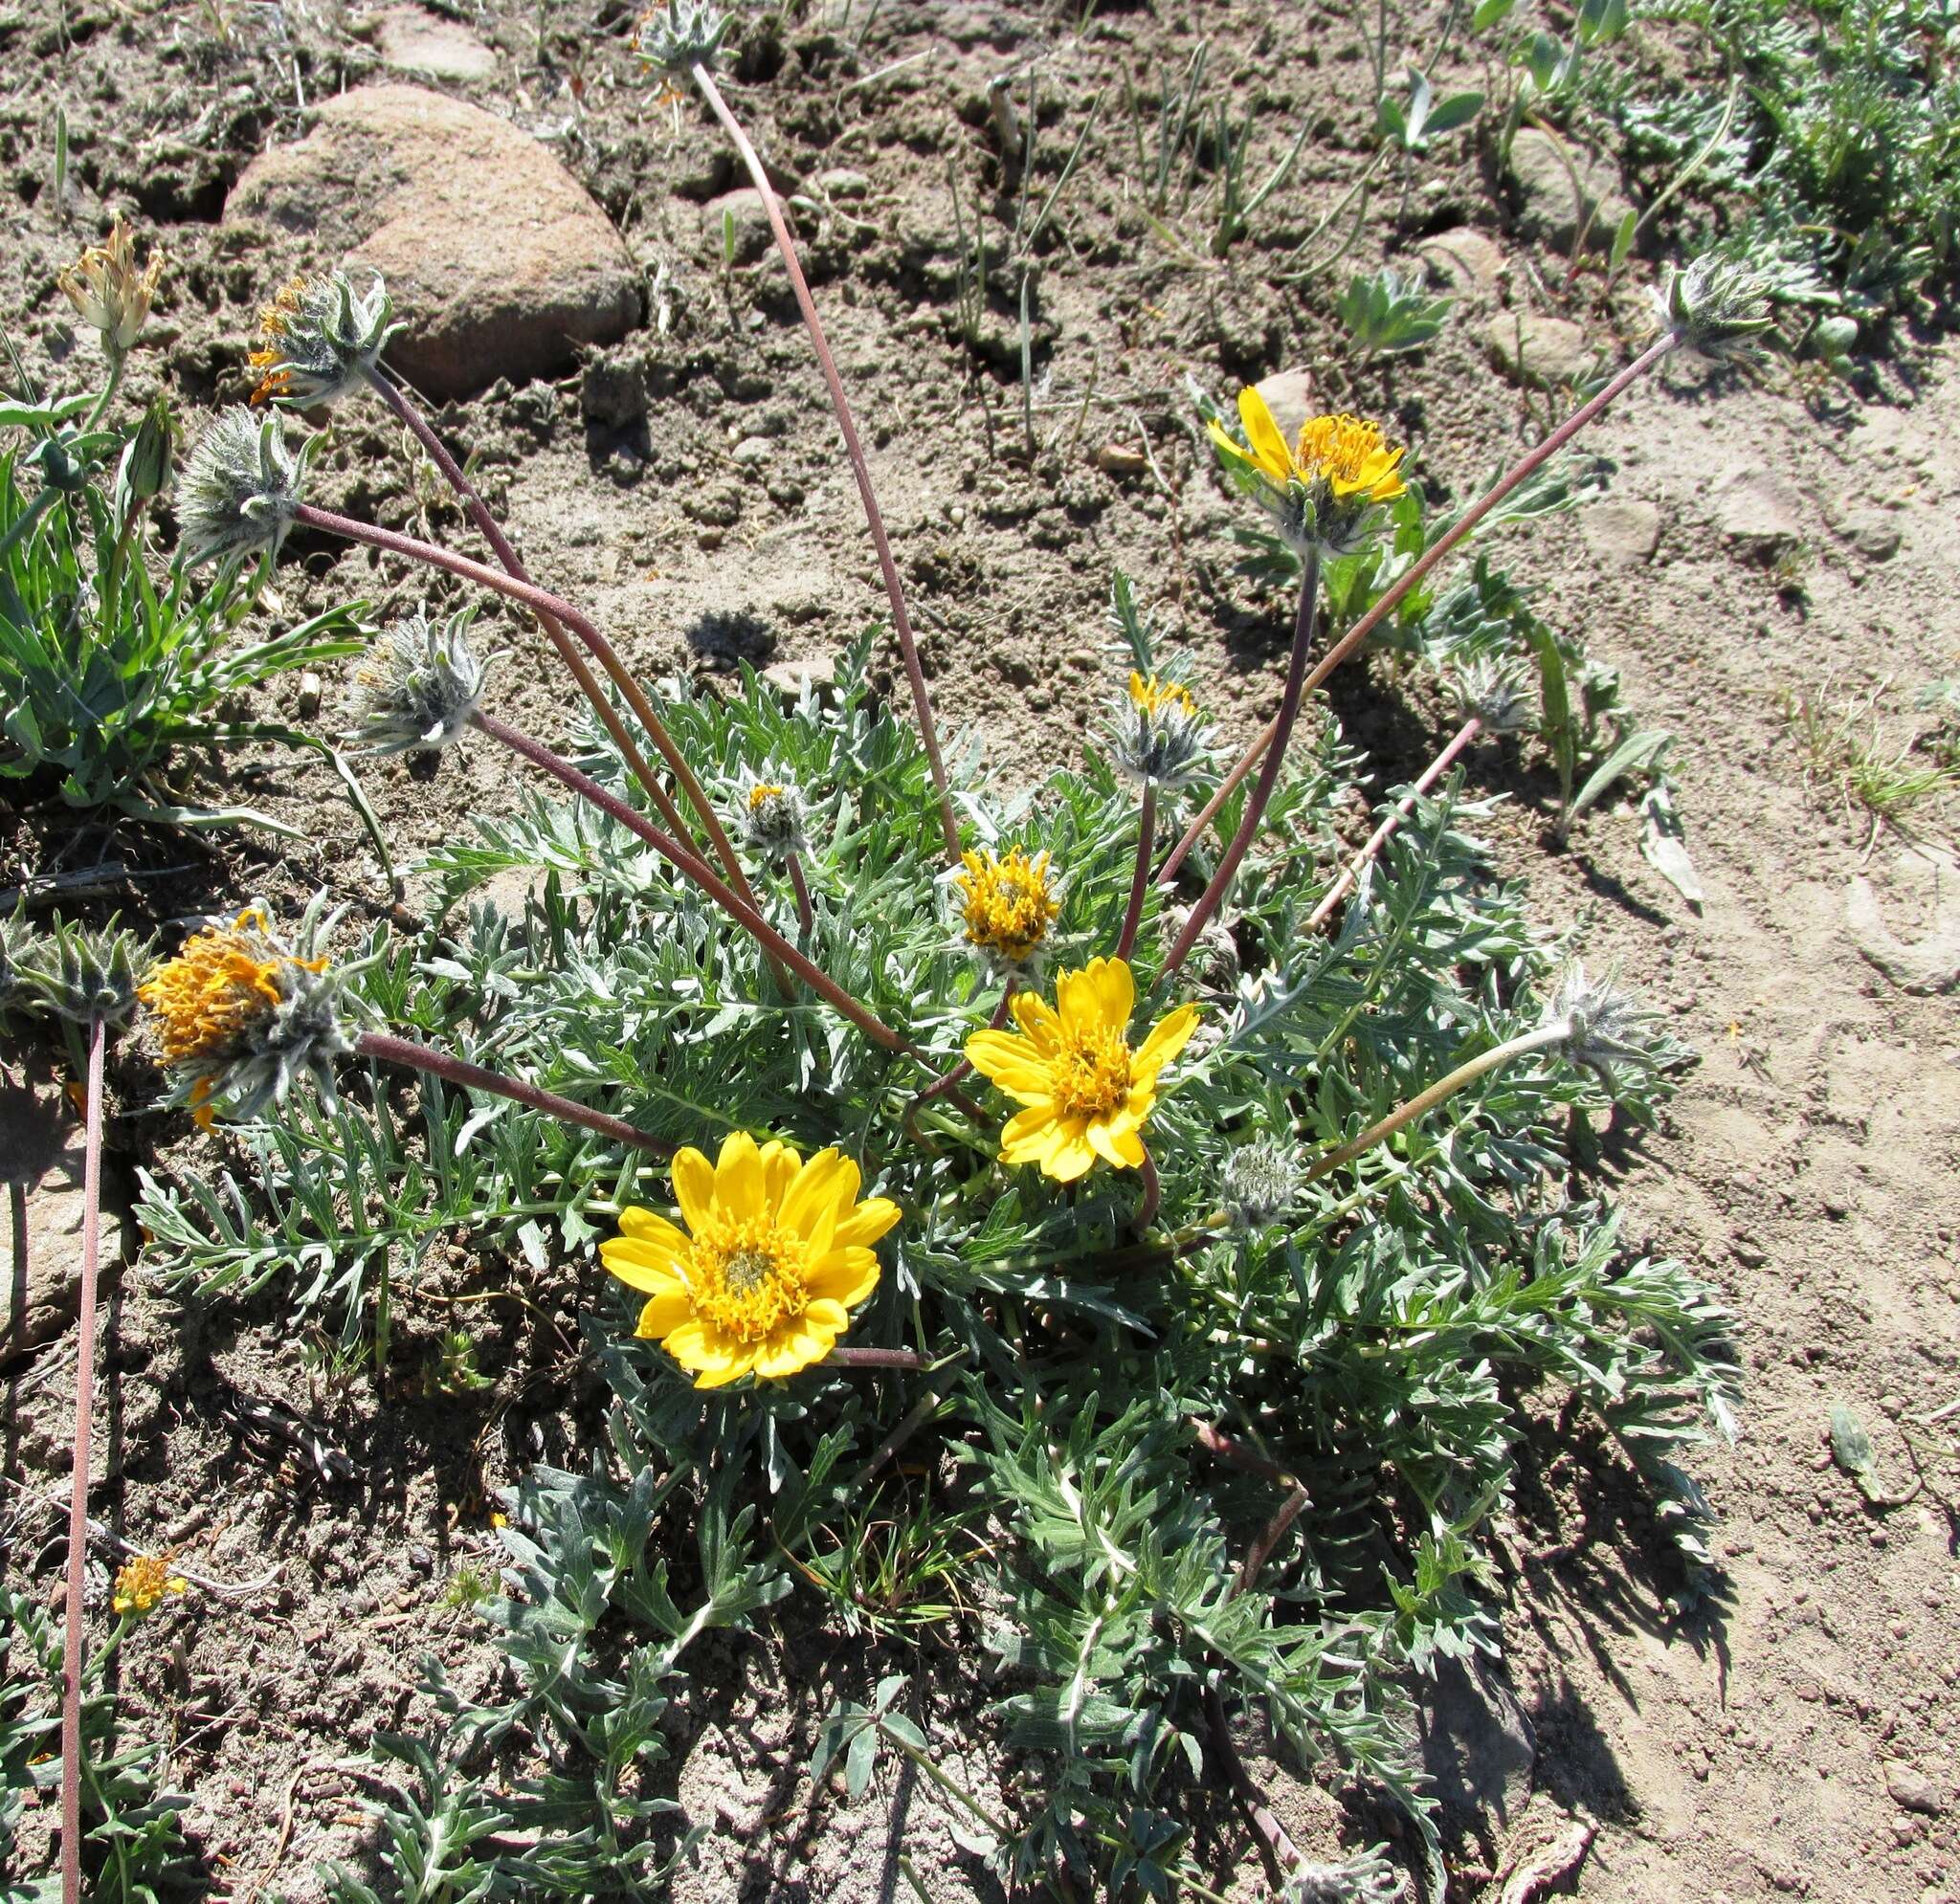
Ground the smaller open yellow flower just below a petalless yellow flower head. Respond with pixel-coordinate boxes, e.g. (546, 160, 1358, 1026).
(967, 958, 1197, 1184)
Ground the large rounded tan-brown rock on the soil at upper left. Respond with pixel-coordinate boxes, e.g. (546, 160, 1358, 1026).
(226, 86, 639, 398)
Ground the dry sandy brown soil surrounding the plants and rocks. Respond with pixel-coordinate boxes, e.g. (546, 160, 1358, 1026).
(0, 0, 1960, 1904)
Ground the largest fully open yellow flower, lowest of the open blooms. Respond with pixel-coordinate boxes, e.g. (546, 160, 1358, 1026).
(600, 1130, 898, 1389)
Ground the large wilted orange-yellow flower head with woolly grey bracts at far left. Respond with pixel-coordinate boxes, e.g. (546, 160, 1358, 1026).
(139, 899, 353, 1124)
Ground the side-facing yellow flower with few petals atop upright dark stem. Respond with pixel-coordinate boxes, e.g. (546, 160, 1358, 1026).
(1212, 384, 1403, 556)
